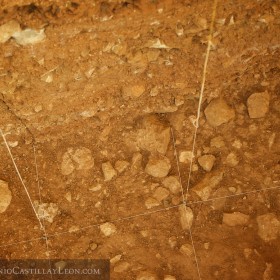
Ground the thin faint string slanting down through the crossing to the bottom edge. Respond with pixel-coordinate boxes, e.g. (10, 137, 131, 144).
(170, 127, 201, 279)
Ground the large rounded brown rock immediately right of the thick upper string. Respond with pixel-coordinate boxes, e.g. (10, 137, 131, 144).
(204, 98, 235, 127)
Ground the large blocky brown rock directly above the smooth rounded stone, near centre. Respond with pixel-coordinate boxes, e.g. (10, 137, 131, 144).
(136, 115, 170, 155)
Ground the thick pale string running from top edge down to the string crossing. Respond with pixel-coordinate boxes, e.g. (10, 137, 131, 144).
(186, 0, 218, 201)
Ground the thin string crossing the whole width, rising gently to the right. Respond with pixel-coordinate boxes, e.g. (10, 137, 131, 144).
(0, 186, 280, 248)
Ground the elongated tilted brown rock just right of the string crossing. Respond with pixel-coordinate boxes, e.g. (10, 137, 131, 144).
(192, 171, 223, 201)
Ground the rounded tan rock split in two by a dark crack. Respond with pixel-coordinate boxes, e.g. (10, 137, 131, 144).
(61, 147, 94, 175)
